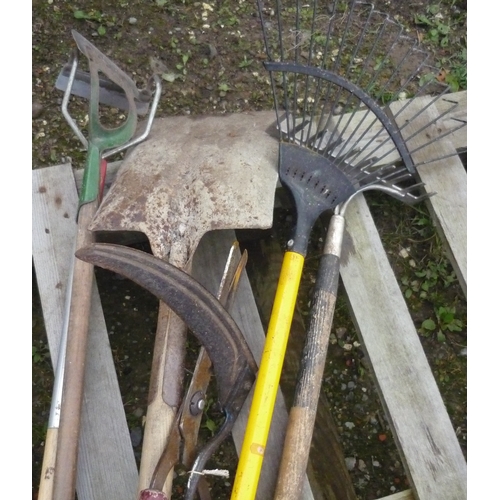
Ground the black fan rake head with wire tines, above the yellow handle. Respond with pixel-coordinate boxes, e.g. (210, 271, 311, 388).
(257, 0, 465, 253)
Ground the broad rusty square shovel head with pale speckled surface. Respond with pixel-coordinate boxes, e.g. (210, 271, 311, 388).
(91, 113, 278, 267)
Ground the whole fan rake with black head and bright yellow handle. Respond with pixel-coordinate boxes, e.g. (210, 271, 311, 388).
(231, 0, 464, 500)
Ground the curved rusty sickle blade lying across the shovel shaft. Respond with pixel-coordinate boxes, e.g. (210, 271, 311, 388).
(76, 243, 257, 412)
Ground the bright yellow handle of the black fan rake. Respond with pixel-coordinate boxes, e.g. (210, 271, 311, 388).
(231, 252, 304, 500)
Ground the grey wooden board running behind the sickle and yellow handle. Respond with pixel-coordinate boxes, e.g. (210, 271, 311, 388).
(193, 230, 314, 500)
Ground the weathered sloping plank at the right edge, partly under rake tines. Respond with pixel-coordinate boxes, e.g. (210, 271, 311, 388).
(392, 98, 467, 296)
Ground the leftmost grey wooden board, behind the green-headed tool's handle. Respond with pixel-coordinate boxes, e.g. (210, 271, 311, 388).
(32, 165, 138, 500)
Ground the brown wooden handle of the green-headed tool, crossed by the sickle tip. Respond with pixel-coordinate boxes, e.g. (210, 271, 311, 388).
(53, 200, 98, 500)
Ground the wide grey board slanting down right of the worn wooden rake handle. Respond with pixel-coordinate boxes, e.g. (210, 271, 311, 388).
(341, 196, 467, 500)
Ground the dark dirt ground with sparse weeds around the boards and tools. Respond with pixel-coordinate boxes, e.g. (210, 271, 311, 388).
(32, 0, 467, 500)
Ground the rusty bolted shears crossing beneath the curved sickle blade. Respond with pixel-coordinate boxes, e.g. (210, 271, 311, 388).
(141, 242, 248, 500)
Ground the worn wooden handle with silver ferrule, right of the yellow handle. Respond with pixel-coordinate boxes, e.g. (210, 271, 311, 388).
(274, 215, 344, 500)
